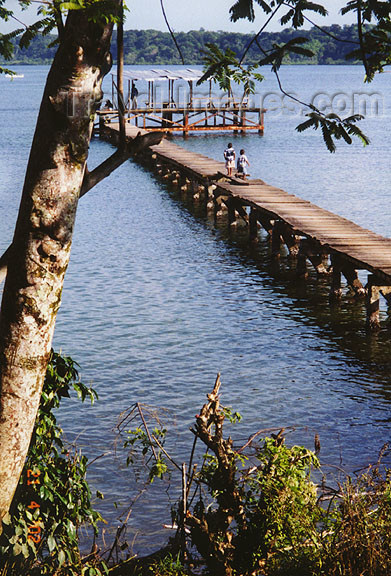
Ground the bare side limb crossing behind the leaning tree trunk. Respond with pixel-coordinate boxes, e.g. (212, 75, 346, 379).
(0, 132, 164, 284)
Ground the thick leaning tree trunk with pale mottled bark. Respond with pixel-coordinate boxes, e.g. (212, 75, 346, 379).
(0, 11, 112, 531)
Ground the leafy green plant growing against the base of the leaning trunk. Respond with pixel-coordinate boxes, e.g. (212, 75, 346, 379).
(0, 352, 106, 576)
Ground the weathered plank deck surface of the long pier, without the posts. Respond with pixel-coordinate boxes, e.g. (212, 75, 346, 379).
(102, 124, 391, 284)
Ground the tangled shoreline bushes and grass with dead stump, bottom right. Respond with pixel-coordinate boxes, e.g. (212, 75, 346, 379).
(120, 377, 391, 576)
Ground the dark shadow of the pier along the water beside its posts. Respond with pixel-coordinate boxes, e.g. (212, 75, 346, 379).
(155, 169, 391, 402)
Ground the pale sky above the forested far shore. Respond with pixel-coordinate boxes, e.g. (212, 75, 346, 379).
(0, 0, 353, 33)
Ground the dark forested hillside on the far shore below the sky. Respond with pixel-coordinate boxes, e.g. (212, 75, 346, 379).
(2, 25, 357, 65)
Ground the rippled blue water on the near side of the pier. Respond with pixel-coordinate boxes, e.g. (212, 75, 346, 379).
(58, 143, 391, 552)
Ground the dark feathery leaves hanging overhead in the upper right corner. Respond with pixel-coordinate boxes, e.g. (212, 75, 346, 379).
(199, 0, 391, 152)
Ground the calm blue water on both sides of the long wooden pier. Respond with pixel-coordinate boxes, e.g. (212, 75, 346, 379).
(0, 66, 391, 551)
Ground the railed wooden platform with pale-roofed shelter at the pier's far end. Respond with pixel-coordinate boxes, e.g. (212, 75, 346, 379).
(98, 68, 266, 135)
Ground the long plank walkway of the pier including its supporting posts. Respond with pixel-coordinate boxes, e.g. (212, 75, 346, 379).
(102, 124, 391, 330)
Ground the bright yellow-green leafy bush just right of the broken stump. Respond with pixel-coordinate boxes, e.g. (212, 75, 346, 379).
(240, 438, 322, 576)
